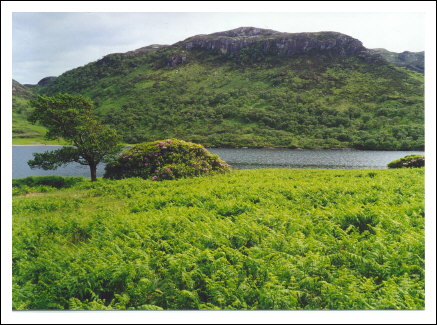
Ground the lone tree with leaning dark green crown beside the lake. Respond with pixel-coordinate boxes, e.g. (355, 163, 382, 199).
(28, 94, 122, 181)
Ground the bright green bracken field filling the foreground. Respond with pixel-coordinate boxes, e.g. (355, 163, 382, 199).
(13, 169, 425, 310)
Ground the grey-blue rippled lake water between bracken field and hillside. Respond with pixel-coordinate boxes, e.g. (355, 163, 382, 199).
(12, 146, 423, 178)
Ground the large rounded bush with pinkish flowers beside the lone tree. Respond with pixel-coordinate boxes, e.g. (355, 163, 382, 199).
(103, 139, 230, 181)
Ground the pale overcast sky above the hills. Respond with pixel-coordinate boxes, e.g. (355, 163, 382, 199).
(12, 8, 425, 84)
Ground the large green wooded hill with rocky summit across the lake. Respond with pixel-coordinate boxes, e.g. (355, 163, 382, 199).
(14, 27, 424, 149)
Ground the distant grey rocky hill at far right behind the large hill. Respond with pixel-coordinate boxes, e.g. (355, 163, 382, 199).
(370, 49, 425, 74)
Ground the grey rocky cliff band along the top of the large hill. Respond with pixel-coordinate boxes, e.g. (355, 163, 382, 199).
(175, 27, 366, 55)
